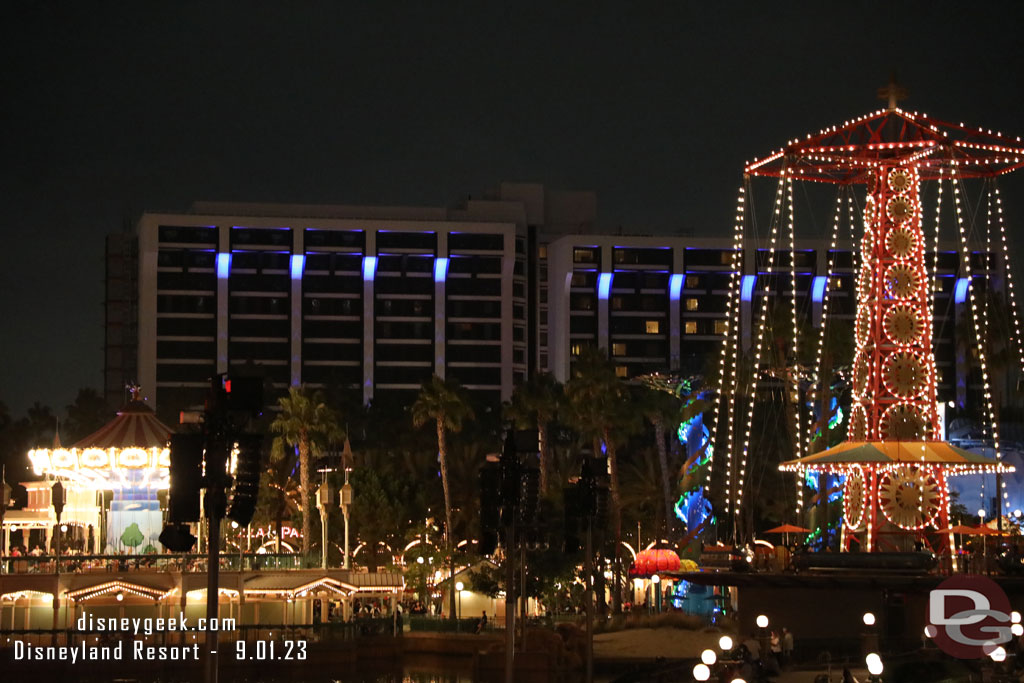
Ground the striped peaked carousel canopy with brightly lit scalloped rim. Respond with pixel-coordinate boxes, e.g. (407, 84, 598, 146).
(29, 399, 171, 489)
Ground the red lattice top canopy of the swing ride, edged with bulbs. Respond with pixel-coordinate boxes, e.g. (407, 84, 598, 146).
(744, 108, 1024, 184)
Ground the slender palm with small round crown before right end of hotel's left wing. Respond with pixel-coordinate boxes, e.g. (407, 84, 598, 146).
(413, 375, 475, 618)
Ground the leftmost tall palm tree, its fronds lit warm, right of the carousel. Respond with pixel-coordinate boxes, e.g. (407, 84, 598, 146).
(270, 385, 342, 556)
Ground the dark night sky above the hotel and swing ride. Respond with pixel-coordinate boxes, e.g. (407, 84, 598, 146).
(0, 1, 1024, 414)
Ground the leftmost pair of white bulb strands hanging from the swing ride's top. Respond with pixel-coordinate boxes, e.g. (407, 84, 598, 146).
(705, 185, 746, 513)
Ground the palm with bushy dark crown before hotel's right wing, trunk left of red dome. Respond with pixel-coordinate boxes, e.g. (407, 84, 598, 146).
(565, 346, 637, 612)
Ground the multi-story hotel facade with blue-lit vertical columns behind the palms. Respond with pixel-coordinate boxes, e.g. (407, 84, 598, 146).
(114, 183, 1009, 419)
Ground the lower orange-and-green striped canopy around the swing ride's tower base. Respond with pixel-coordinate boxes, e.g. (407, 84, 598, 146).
(778, 441, 1015, 475)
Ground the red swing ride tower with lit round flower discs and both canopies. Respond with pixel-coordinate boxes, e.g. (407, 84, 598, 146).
(741, 92, 1024, 551)
